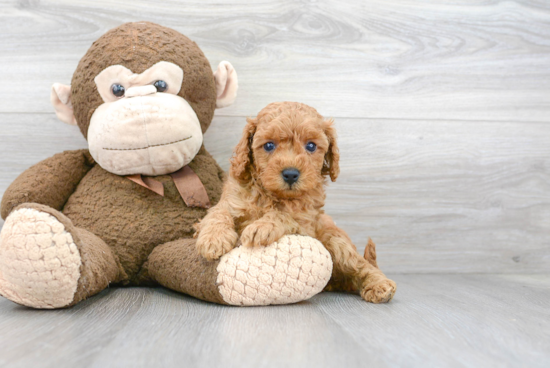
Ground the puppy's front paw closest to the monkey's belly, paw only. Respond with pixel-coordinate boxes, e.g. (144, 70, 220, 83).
(196, 227, 239, 261)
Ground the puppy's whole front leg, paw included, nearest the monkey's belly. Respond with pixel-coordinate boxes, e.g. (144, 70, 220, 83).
(195, 201, 239, 260)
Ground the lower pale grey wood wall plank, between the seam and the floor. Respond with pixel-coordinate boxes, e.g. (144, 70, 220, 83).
(0, 114, 550, 273)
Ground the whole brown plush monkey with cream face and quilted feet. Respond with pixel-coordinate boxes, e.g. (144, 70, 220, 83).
(0, 22, 331, 308)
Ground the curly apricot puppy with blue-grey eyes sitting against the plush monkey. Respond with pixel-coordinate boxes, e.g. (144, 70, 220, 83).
(196, 102, 396, 303)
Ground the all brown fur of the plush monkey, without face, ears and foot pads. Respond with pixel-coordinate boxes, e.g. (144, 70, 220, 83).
(1, 22, 230, 305)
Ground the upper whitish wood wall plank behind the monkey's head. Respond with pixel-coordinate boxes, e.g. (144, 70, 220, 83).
(0, 0, 550, 122)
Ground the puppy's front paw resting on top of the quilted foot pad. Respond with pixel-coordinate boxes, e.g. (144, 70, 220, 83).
(241, 211, 299, 247)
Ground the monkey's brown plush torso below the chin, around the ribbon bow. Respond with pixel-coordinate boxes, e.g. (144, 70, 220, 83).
(63, 148, 223, 283)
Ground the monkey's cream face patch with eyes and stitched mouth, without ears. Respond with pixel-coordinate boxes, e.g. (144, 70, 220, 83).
(88, 61, 203, 175)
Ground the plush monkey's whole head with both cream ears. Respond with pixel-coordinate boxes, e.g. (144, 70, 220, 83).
(51, 22, 238, 176)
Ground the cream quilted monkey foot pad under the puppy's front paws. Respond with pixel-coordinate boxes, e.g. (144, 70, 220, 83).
(217, 235, 332, 306)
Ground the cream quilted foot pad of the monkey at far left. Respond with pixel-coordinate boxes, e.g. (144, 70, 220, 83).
(0, 208, 81, 309)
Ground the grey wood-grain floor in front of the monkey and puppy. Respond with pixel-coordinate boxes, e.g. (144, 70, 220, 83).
(0, 275, 550, 368)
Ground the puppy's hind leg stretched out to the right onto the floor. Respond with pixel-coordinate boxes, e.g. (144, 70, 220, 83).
(317, 215, 396, 303)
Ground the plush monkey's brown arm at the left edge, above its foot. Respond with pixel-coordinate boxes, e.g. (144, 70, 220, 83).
(1, 149, 95, 219)
